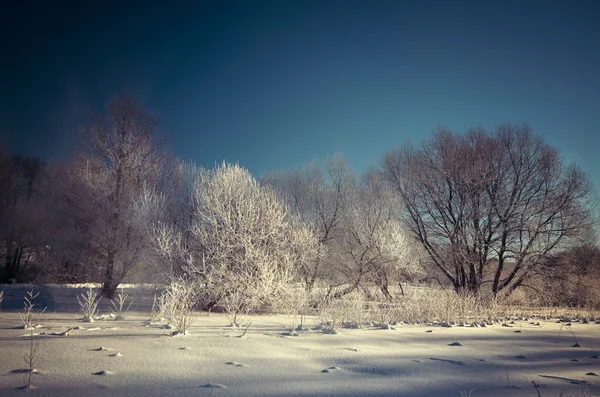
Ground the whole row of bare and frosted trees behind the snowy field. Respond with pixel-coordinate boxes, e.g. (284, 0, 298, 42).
(0, 97, 600, 306)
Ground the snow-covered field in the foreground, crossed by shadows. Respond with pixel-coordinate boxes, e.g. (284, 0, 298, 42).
(0, 285, 600, 397)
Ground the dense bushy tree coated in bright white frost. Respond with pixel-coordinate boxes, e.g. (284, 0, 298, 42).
(138, 164, 317, 305)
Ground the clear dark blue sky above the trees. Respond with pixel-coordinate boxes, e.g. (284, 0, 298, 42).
(0, 0, 600, 189)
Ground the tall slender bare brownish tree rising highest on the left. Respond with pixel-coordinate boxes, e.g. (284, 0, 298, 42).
(66, 96, 170, 298)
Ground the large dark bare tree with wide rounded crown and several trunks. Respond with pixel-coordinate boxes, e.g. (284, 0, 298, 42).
(382, 125, 594, 295)
